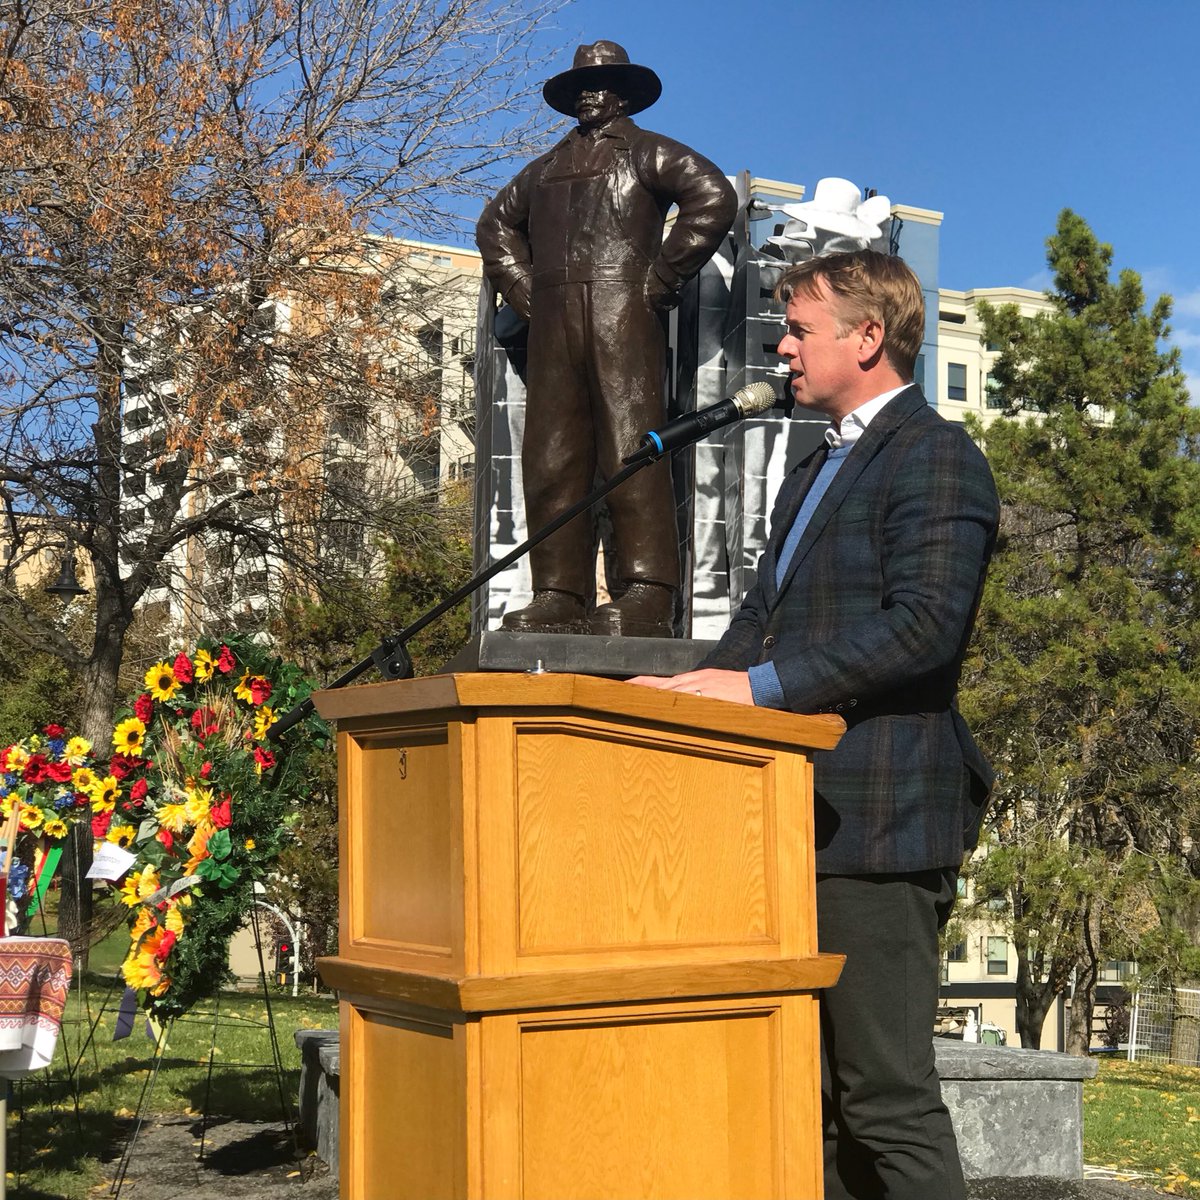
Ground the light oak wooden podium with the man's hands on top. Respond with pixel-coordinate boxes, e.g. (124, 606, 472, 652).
(316, 674, 844, 1200)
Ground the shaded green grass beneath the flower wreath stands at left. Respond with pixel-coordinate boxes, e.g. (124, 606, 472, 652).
(8, 974, 337, 1200)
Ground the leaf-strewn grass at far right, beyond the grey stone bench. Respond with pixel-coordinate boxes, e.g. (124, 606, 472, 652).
(1084, 1060, 1200, 1198)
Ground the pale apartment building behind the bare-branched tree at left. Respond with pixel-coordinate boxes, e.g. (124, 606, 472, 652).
(122, 238, 481, 640)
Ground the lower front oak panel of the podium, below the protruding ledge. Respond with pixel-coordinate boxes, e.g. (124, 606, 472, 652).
(481, 996, 821, 1200)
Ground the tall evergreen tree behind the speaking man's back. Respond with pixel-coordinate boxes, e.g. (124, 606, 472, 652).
(962, 210, 1200, 1052)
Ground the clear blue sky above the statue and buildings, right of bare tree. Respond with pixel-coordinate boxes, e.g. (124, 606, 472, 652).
(506, 0, 1200, 388)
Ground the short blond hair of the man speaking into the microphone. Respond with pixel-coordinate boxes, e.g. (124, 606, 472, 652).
(775, 250, 925, 379)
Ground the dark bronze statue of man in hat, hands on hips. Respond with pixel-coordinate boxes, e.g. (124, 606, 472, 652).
(476, 42, 737, 637)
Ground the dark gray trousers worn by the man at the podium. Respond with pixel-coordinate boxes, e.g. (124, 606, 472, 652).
(817, 868, 966, 1200)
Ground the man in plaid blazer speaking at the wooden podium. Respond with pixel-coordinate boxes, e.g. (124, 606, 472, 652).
(632, 250, 998, 1200)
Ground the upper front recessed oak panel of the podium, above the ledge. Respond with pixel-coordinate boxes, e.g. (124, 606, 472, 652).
(516, 724, 779, 955)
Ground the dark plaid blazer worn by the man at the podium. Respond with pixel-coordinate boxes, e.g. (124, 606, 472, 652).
(701, 386, 1000, 875)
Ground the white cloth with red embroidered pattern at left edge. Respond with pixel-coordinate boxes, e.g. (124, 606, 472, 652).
(0, 937, 71, 1079)
